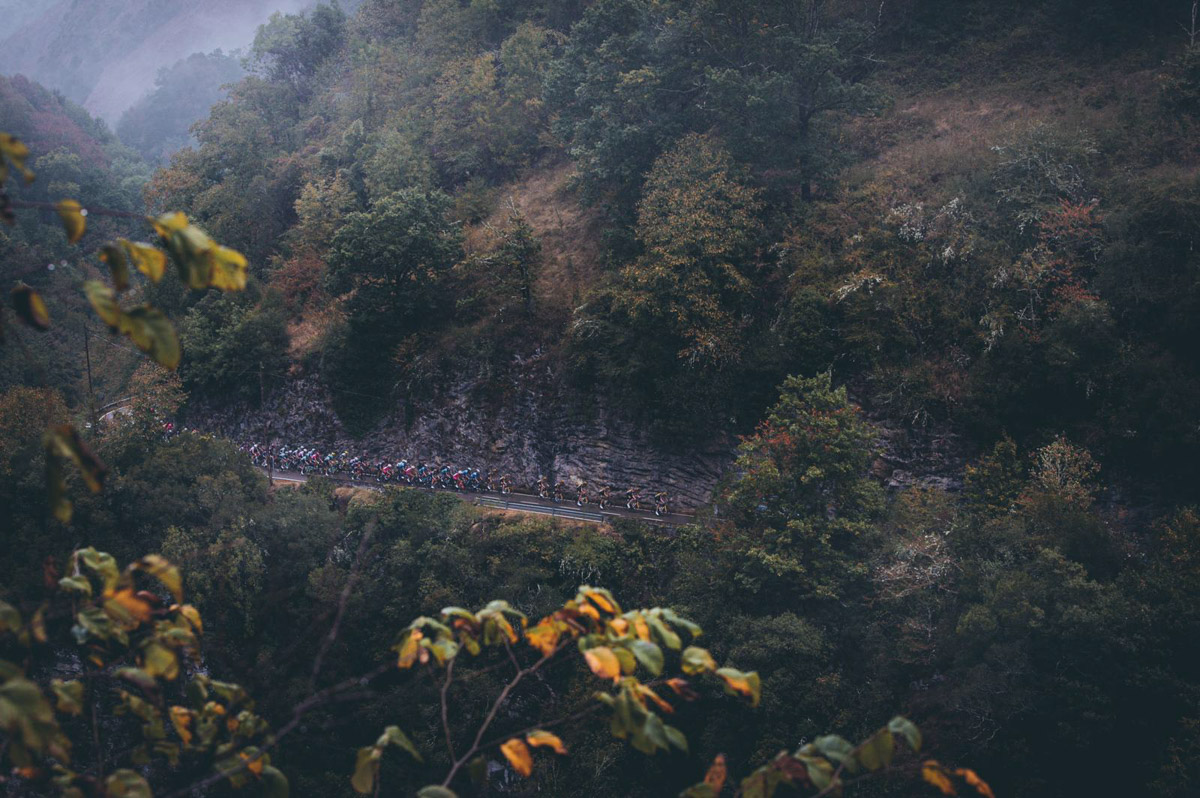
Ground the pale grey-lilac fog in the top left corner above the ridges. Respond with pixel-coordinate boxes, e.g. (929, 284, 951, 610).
(0, 0, 319, 125)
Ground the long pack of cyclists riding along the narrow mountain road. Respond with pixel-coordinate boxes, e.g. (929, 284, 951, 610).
(241, 443, 671, 516)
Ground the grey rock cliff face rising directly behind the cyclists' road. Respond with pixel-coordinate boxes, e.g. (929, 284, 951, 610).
(185, 355, 965, 509)
